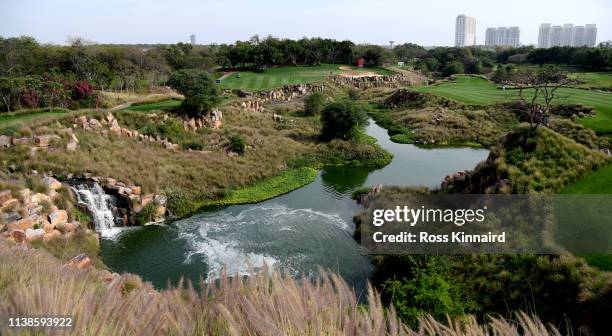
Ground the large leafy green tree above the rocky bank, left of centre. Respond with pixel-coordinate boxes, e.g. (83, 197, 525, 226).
(168, 69, 220, 116)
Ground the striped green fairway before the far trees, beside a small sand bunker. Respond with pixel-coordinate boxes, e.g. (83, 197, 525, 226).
(220, 64, 392, 91)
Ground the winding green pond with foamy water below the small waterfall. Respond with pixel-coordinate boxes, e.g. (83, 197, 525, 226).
(102, 121, 488, 289)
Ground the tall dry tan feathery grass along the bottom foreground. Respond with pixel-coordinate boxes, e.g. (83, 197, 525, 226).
(0, 238, 560, 336)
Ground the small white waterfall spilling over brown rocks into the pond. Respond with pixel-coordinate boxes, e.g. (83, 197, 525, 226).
(72, 183, 117, 232)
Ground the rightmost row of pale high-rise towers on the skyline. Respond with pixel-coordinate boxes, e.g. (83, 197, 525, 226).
(538, 23, 597, 48)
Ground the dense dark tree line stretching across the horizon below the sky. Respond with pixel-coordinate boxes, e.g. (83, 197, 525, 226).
(0, 35, 612, 111)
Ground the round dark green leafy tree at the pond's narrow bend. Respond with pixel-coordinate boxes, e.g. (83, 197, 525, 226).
(321, 100, 368, 140)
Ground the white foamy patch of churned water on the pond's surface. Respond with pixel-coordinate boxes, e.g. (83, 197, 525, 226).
(176, 204, 349, 280)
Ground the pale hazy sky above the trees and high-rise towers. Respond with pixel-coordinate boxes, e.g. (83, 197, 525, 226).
(0, 0, 612, 46)
